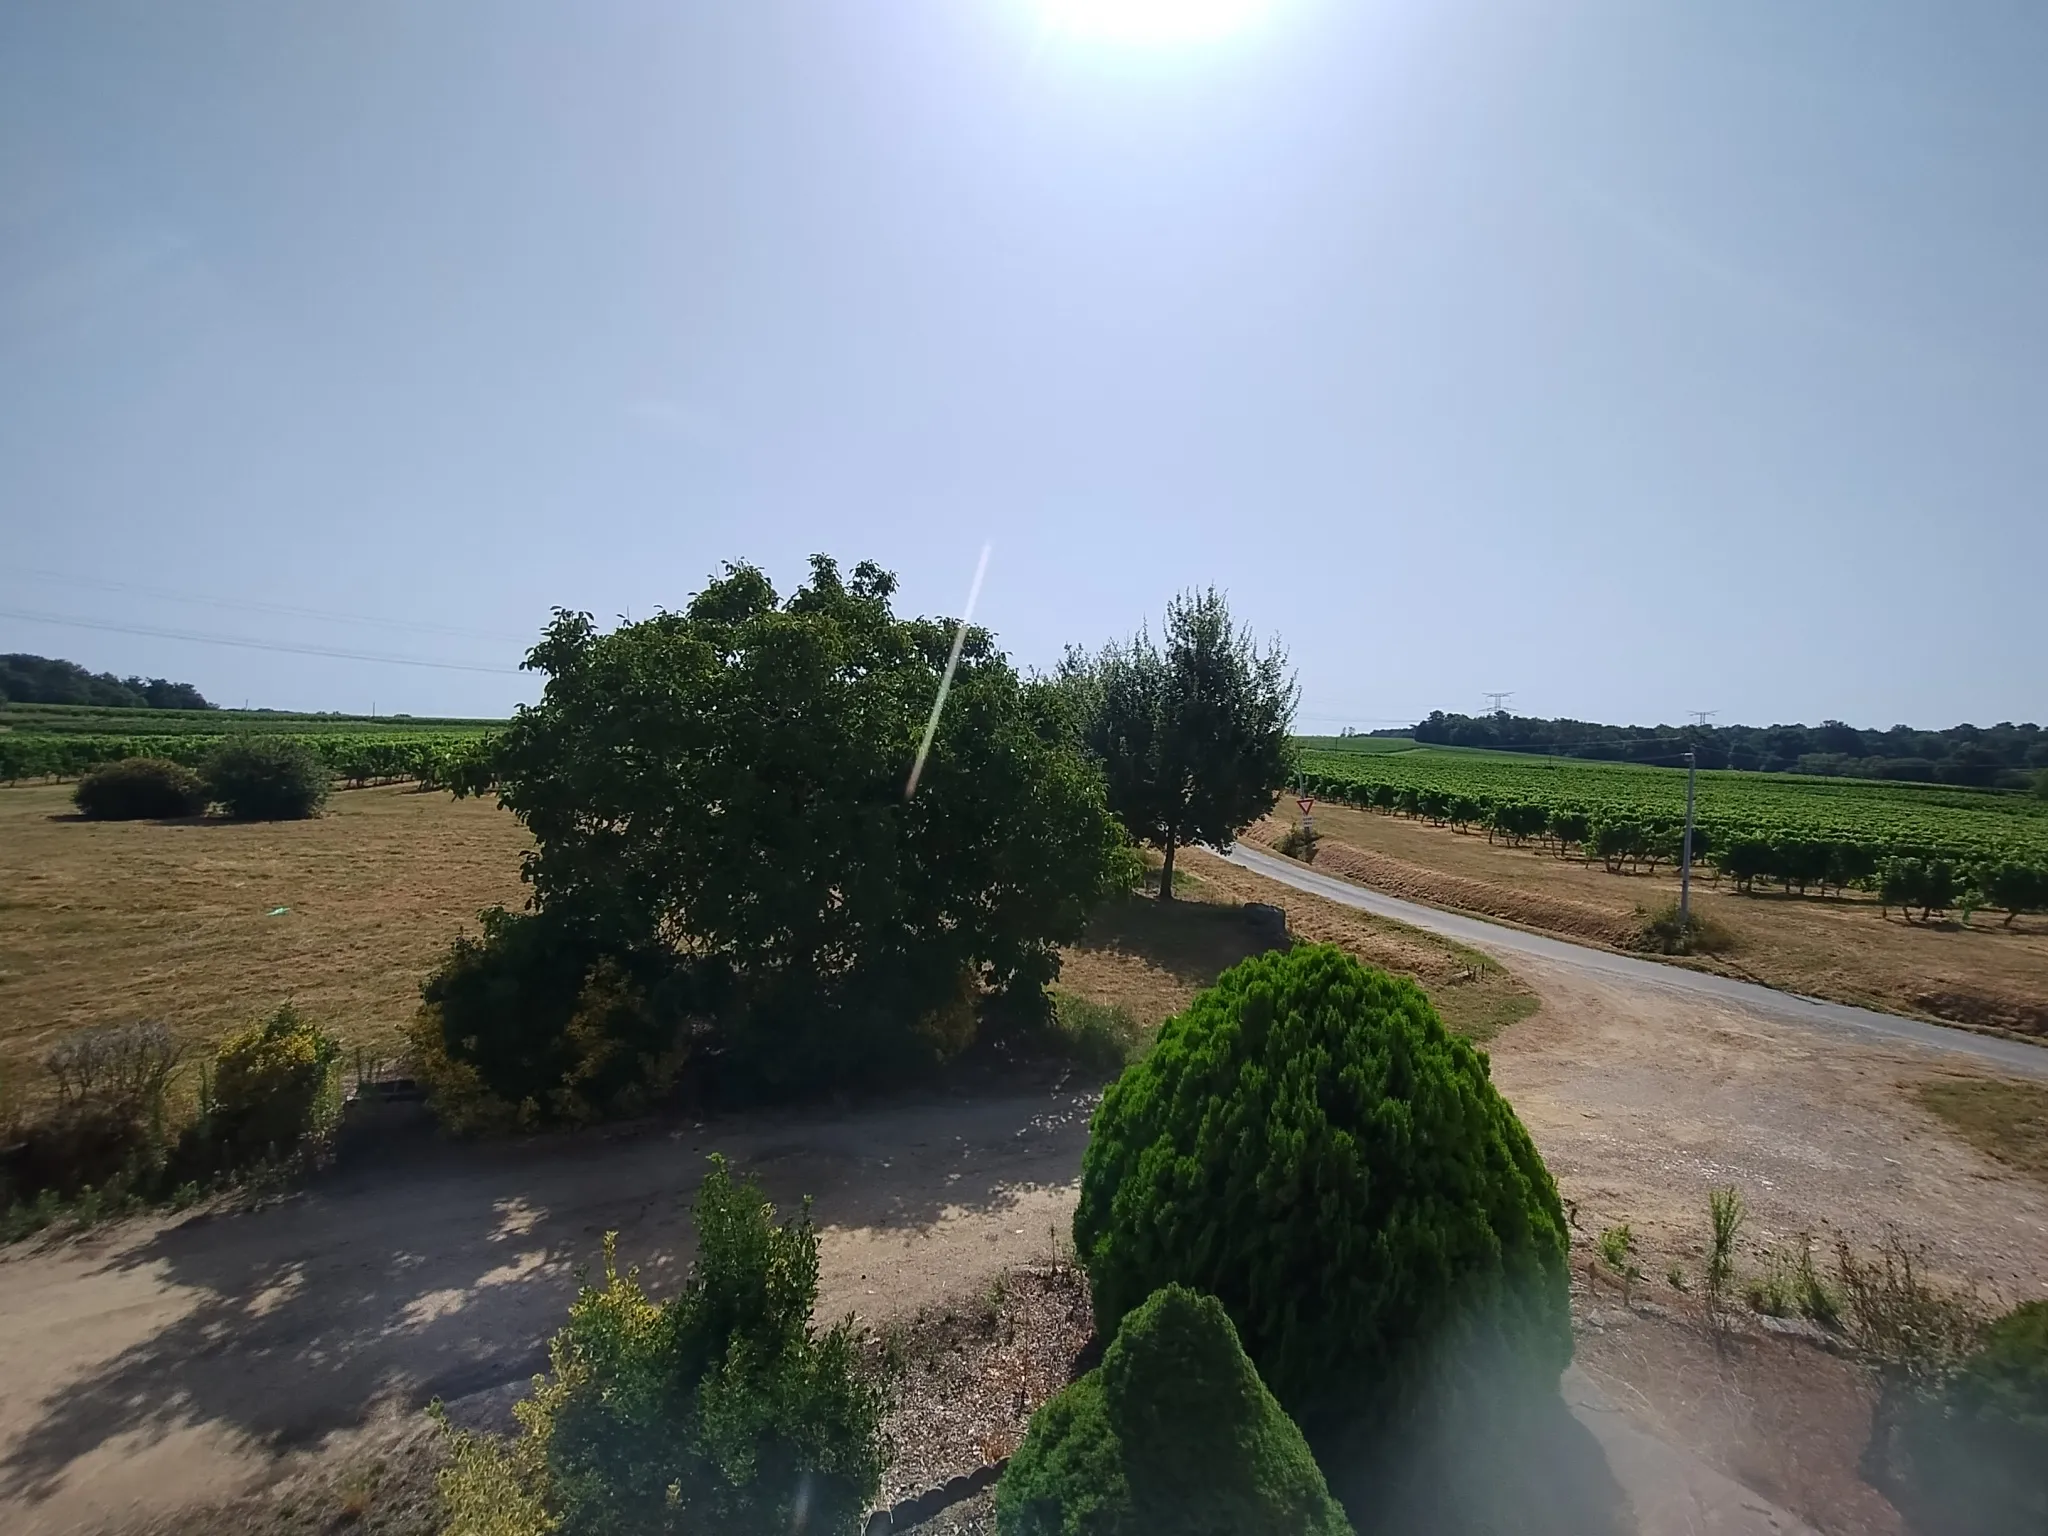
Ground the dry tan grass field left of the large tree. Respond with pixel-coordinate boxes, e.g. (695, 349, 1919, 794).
(0, 784, 526, 1092)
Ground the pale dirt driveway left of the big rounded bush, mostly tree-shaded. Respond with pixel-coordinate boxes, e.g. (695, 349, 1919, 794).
(0, 1081, 1096, 1536)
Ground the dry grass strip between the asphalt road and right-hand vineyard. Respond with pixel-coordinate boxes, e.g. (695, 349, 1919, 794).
(1249, 801, 2048, 1036)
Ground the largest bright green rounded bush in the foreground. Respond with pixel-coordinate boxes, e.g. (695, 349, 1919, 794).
(1073, 944, 1571, 1444)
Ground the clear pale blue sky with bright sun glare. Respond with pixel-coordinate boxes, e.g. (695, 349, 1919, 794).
(0, 0, 2048, 729)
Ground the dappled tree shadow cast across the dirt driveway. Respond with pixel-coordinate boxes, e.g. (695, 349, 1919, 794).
(0, 1087, 1092, 1501)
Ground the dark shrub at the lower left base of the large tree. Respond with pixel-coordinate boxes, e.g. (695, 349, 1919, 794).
(408, 907, 688, 1133)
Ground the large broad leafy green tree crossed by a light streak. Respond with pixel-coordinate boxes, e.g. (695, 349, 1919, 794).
(496, 555, 1122, 1092)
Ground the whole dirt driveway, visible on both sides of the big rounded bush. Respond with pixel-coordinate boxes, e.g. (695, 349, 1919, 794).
(0, 874, 2048, 1534)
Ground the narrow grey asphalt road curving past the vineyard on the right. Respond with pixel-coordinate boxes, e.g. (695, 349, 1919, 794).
(1223, 844, 2048, 1079)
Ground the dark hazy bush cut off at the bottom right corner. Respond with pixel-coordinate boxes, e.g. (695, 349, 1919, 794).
(1903, 1300, 2048, 1536)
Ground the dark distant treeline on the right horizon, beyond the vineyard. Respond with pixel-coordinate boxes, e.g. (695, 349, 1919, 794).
(1405, 711, 2048, 788)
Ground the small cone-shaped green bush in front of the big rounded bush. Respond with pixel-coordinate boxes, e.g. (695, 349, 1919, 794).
(995, 1286, 1350, 1536)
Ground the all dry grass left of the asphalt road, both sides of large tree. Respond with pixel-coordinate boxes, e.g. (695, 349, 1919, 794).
(0, 786, 1536, 1094)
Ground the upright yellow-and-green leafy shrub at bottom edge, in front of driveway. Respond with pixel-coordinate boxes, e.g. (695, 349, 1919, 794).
(440, 1157, 885, 1536)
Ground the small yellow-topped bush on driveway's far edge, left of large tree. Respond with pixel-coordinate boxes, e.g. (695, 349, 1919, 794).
(205, 1004, 342, 1163)
